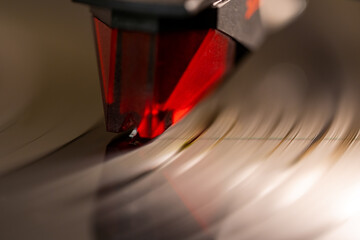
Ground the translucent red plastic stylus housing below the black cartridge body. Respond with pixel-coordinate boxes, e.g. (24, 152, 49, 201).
(94, 18, 235, 138)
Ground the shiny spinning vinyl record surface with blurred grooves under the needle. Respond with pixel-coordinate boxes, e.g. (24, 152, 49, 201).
(0, 0, 360, 240)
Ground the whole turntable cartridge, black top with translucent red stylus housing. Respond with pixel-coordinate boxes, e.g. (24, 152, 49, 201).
(74, 0, 264, 139)
